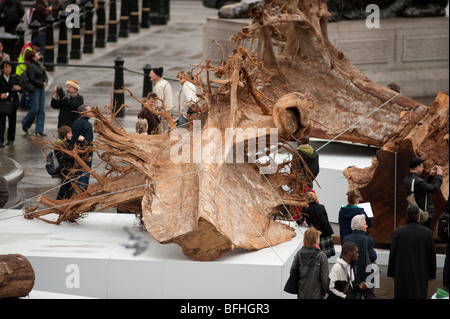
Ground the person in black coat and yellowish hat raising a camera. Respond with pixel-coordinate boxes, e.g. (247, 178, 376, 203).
(50, 80, 84, 129)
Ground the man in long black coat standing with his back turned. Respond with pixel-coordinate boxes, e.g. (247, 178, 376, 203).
(387, 206, 436, 299)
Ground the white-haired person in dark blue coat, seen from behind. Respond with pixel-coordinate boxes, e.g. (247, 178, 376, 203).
(342, 214, 377, 299)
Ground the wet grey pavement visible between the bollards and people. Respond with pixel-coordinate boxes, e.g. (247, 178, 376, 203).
(0, 0, 442, 299)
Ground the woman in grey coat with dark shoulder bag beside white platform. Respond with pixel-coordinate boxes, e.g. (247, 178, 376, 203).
(290, 227, 328, 299)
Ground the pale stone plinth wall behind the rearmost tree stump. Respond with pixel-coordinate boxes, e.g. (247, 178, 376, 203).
(203, 17, 449, 98)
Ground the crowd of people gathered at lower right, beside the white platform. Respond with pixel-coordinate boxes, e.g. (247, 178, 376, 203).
(284, 151, 449, 299)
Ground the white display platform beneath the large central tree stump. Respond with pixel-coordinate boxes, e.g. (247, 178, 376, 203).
(0, 210, 304, 299)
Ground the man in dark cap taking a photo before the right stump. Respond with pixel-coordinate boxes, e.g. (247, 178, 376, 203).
(403, 158, 442, 228)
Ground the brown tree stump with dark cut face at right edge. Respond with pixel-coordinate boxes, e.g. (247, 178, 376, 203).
(344, 92, 449, 243)
